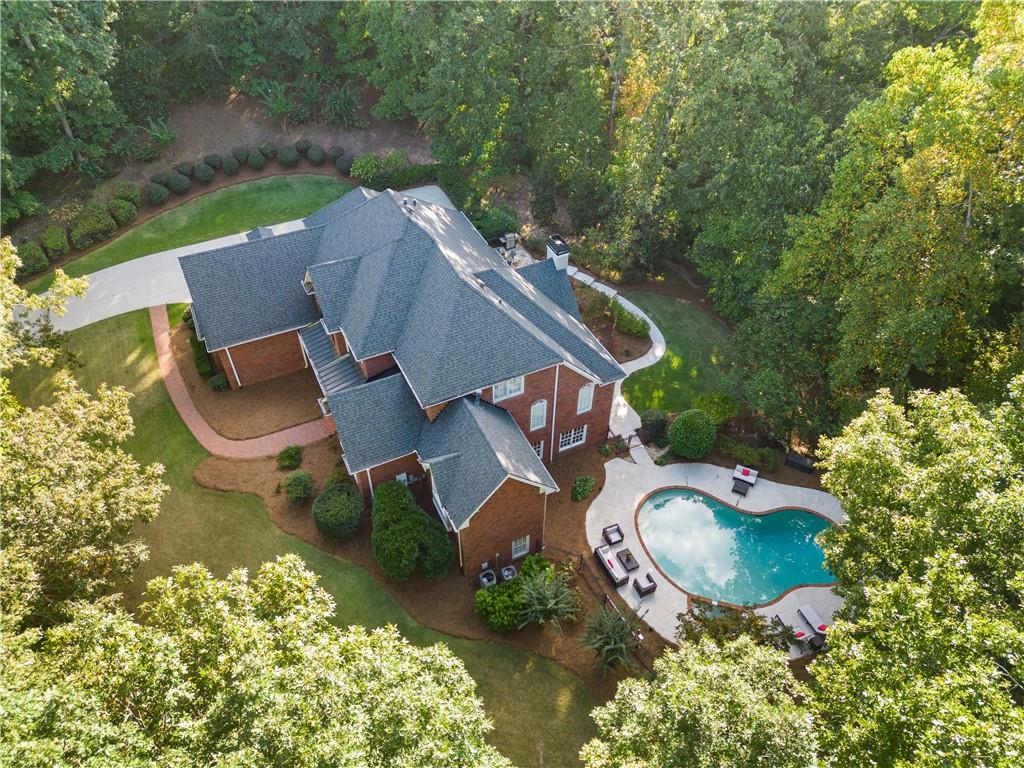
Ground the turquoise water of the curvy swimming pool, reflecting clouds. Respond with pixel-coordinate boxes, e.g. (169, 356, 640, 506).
(637, 488, 836, 605)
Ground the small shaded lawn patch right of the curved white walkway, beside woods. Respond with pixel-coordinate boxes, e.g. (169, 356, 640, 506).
(623, 292, 731, 413)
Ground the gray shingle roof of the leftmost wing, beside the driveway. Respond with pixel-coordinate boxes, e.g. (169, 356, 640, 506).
(179, 228, 321, 351)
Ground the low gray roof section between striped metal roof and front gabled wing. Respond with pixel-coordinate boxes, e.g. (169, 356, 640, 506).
(327, 373, 427, 472)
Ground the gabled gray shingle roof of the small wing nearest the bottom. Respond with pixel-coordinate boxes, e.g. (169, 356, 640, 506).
(419, 397, 558, 528)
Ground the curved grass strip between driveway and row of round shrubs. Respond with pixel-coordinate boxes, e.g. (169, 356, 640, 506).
(28, 174, 352, 293)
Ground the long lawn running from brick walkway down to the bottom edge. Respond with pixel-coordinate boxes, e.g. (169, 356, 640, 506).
(12, 306, 596, 766)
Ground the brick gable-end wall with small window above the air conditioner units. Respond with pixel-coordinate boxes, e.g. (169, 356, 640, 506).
(461, 478, 545, 579)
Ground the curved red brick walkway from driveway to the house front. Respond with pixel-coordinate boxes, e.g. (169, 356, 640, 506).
(150, 304, 334, 459)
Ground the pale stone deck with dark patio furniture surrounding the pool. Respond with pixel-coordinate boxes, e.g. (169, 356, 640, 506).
(587, 459, 846, 655)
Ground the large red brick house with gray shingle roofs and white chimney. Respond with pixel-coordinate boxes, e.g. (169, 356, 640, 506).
(180, 186, 625, 577)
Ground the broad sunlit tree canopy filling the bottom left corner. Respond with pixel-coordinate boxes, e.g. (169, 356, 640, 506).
(0, 556, 508, 768)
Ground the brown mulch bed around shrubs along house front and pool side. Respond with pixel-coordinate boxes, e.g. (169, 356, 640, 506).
(195, 437, 666, 700)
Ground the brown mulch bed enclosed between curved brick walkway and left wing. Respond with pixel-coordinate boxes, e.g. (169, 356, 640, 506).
(171, 323, 324, 440)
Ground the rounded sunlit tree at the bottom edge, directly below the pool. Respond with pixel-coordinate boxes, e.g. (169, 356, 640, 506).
(581, 637, 817, 768)
